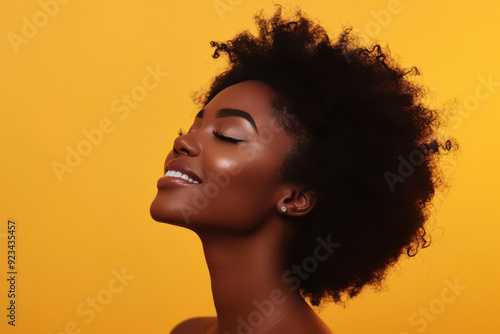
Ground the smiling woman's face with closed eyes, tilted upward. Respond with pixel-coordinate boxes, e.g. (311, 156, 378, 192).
(150, 81, 293, 232)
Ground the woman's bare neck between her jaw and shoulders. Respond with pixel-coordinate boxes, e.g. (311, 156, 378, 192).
(194, 218, 310, 334)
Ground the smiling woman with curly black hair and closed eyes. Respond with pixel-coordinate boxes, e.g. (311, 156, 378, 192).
(151, 7, 454, 334)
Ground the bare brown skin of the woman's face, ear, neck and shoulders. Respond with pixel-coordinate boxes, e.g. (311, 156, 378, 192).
(150, 81, 332, 334)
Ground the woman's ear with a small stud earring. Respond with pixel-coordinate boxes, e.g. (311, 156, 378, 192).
(276, 185, 318, 216)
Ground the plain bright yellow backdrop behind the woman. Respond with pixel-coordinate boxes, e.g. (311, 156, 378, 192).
(0, 0, 500, 334)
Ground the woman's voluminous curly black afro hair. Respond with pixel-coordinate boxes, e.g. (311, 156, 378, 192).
(193, 5, 458, 306)
